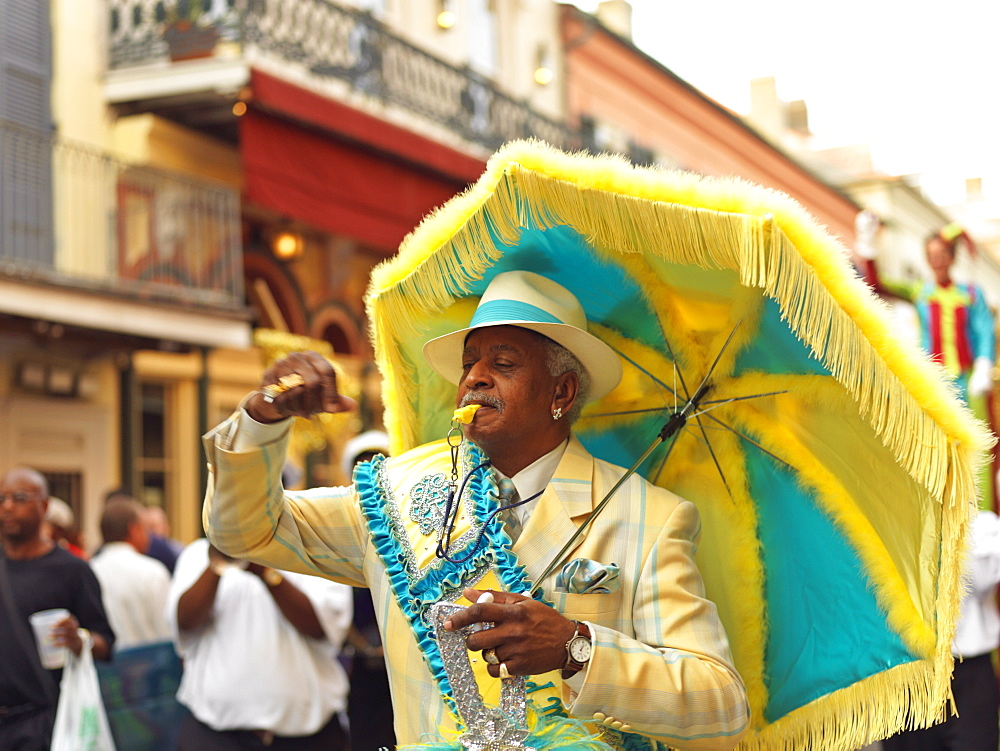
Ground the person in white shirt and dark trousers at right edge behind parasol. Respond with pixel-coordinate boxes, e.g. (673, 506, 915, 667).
(882, 512, 1000, 751)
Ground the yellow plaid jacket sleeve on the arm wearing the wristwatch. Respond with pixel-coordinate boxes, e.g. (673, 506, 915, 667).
(571, 501, 749, 749)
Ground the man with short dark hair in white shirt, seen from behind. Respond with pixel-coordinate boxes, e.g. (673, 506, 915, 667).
(90, 500, 170, 649)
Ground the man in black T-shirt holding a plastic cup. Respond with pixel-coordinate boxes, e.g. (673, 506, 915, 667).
(0, 467, 115, 751)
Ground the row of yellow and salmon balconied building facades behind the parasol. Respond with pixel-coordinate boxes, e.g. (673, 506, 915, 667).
(0, 0, 857, 546)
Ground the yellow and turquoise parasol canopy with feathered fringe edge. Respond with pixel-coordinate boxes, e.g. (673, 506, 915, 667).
(368, 142, 991, 750)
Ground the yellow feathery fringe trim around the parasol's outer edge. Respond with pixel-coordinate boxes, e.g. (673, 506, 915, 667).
(366, 141, 993, 750)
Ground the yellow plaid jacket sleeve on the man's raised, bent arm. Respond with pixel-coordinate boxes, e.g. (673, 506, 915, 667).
(202, 413, 368, 586)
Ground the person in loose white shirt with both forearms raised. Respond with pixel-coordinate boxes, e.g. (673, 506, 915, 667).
(167, 539, 352, 751)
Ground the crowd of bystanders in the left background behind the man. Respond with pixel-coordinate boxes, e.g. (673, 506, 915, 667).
(0, 431, 394, 751)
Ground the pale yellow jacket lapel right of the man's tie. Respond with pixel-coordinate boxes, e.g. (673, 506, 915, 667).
(514, 437, 594, 589)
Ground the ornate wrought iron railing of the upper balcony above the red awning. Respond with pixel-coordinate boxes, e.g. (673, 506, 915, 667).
(109, 0, 573, 150)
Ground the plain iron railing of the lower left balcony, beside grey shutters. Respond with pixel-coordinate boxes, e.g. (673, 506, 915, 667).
(0, 121, 244, 311)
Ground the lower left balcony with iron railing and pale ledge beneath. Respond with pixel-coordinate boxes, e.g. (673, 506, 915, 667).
(0, 122, 249, 345)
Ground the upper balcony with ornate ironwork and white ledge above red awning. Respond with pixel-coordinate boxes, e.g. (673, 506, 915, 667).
(108, 0, 572, 152)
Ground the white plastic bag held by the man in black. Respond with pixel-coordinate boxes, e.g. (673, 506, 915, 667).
(51, 629, 115, 751)
